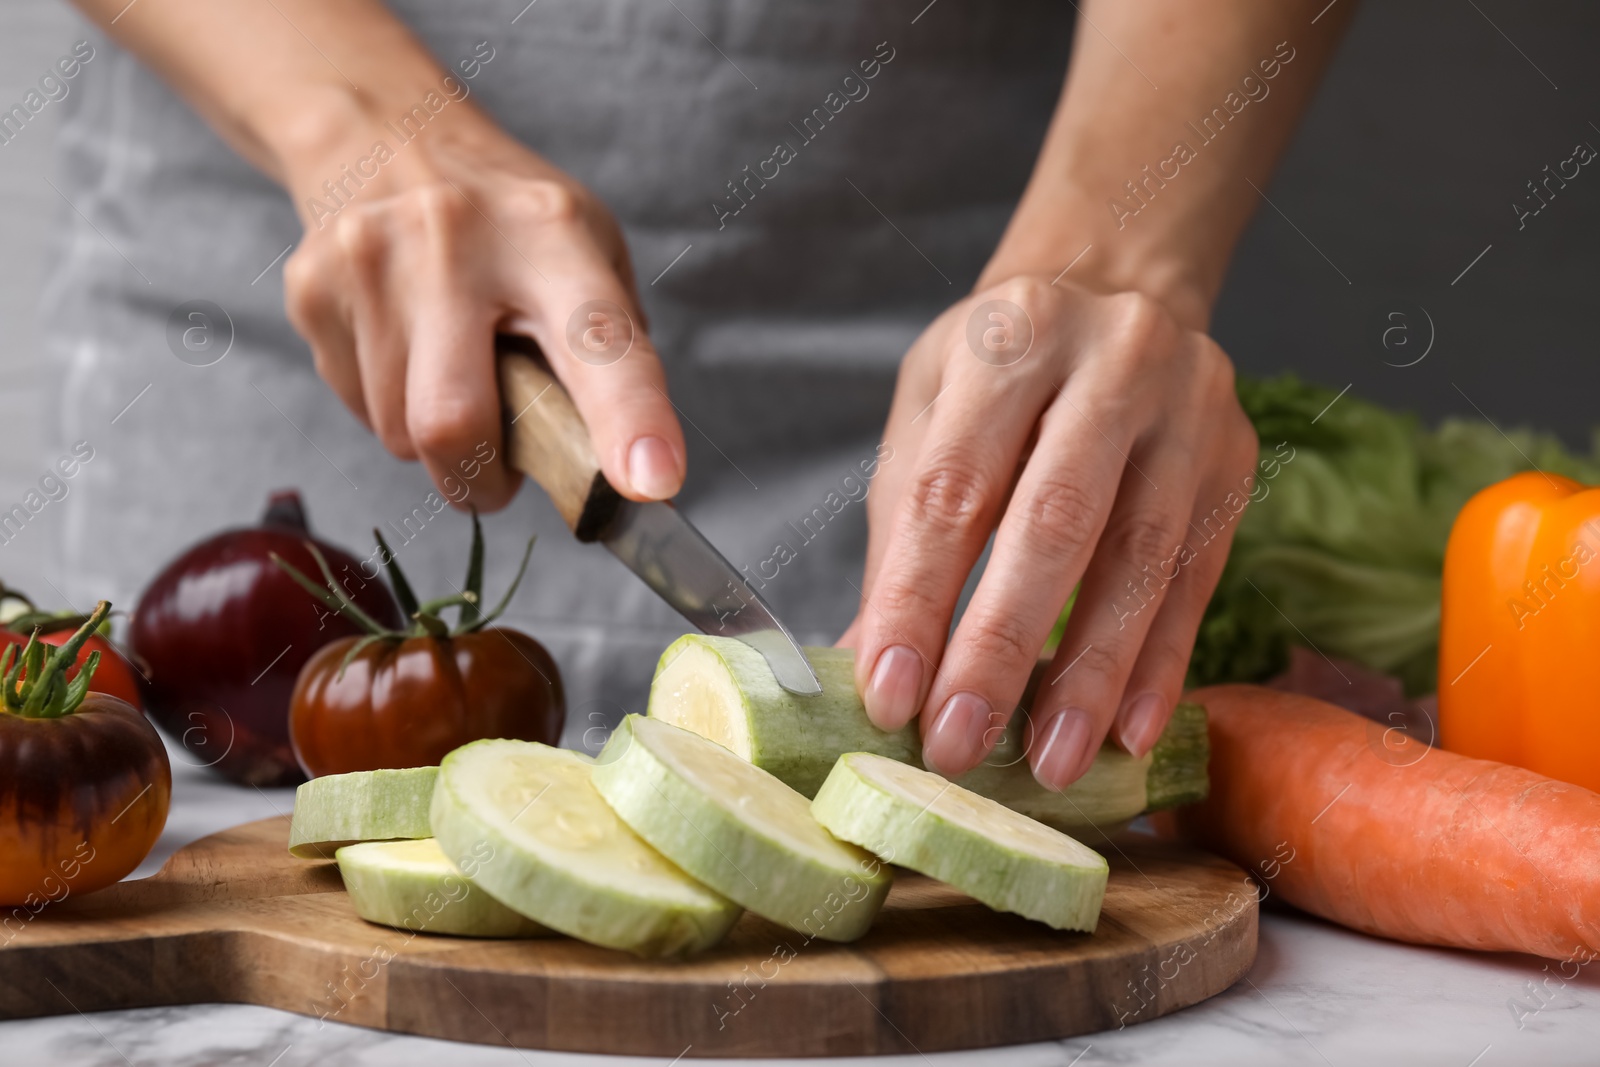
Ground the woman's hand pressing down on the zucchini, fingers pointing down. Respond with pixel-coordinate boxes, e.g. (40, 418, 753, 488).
(840, 275, 1258, 789)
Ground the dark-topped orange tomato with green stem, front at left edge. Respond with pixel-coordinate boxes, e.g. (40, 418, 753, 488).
(0, 601, 173, 908)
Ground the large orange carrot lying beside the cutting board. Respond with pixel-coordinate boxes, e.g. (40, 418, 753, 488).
(1176, 685, 1600, 961)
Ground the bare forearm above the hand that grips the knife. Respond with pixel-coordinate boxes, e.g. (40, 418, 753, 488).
(74, 0, 489, 200)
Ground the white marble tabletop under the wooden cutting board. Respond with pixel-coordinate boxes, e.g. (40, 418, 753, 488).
(0, 750, 1600, 1067)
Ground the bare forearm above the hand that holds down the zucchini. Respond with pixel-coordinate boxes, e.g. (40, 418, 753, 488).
(979, 0, 1354, 330)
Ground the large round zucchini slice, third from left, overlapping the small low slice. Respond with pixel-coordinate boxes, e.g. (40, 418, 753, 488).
(432, 741, 739, 957)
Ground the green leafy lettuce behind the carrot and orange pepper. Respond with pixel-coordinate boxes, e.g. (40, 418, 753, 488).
(1189, 374, 1600, 696)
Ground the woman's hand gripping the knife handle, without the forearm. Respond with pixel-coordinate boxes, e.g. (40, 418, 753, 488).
(282, 94, 685, 509)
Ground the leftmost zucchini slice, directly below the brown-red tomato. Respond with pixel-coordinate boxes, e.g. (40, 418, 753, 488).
(290, 766, 438, 859)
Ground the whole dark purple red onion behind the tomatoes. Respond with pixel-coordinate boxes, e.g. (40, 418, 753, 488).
(128, 490, 402, 785)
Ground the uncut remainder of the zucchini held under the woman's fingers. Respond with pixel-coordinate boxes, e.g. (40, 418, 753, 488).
(650, 633, 1208, 840)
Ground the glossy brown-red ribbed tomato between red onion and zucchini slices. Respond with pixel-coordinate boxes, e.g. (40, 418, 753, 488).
(290, 627, 566, 777)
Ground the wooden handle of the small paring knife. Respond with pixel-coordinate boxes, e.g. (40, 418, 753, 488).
(494, 334, 622, 541)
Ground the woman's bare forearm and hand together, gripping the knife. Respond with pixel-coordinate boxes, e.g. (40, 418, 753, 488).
(65, 0, 685, 509)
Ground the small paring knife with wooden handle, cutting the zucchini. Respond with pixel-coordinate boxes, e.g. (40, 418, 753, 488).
(494, 334, 822, 694)
